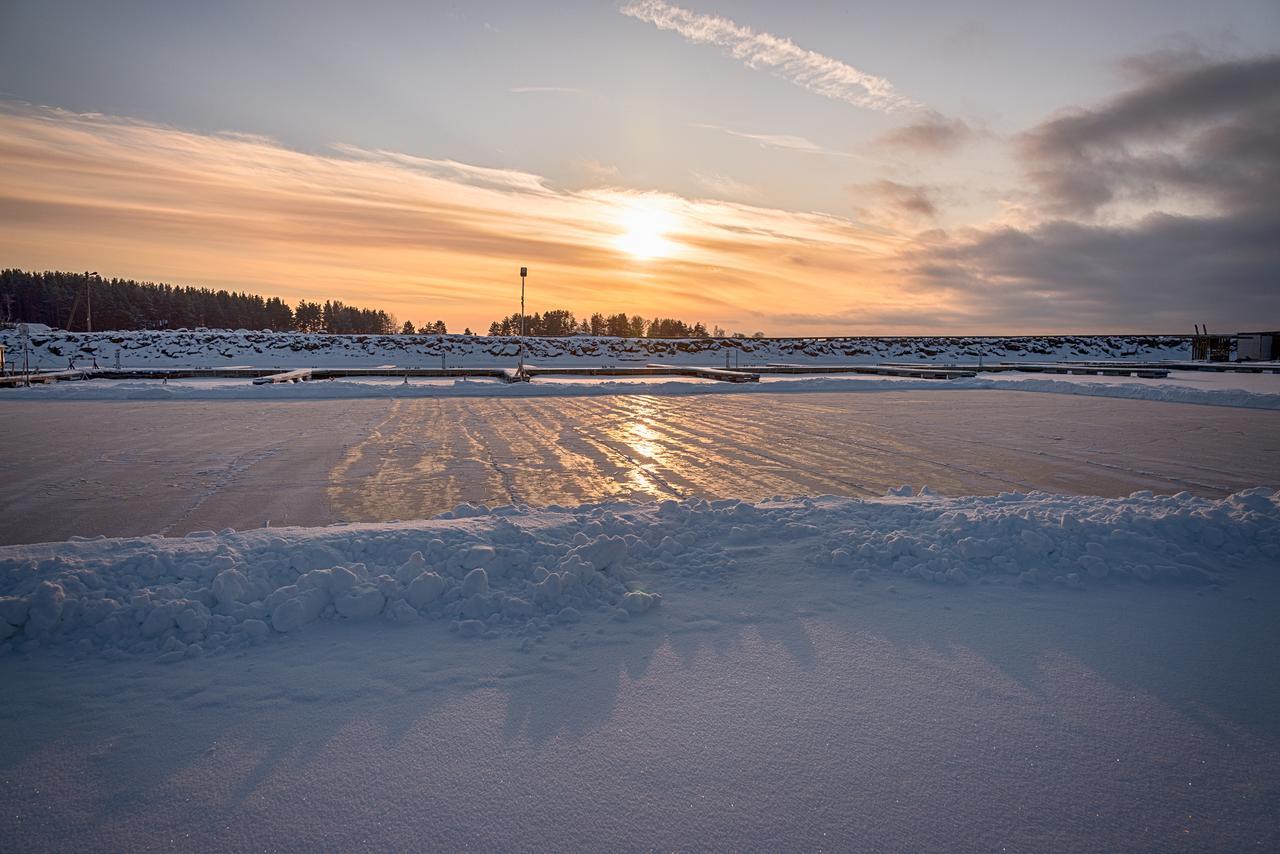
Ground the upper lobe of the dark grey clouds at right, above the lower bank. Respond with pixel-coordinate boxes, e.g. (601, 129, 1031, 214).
(1018, 56, 1280, 216)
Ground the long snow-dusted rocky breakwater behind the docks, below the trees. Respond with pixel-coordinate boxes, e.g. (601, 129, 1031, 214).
(0, 329, 1190, 370)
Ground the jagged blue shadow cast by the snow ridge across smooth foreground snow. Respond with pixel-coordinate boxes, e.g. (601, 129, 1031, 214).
(0, 558, 1280, 839)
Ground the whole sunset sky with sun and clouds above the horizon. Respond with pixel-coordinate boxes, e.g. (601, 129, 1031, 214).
(0, 0, 1280, 335)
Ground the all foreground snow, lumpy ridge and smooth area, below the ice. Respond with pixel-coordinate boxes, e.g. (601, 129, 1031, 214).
(0, 488, 1280, 850)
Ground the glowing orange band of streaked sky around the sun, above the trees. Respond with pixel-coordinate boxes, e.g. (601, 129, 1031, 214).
(0, 109, 940, 334)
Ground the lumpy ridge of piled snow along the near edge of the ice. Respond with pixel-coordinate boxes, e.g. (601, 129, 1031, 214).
(0, 487, 1280, 662)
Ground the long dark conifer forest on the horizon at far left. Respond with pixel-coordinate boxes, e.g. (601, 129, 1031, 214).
(0, 270, 409, 335)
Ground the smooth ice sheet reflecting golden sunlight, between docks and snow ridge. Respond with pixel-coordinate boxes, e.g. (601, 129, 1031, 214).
(0, 391, 1280, 543)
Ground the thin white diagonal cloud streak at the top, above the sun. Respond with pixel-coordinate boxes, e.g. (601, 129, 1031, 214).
(621, 0, 918, 113)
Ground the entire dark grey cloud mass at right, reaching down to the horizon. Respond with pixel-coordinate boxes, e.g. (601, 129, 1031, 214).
(906, 55, 1280, 332)
